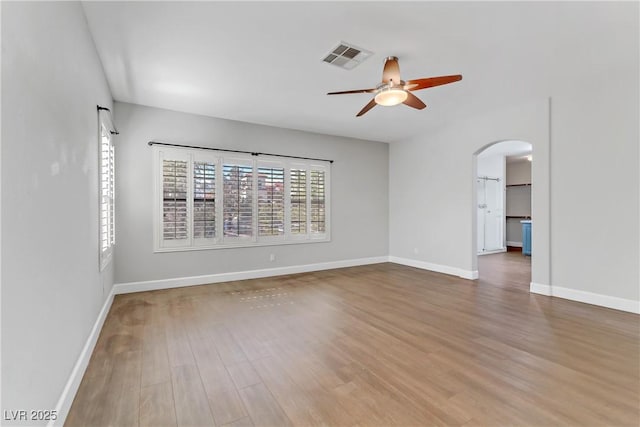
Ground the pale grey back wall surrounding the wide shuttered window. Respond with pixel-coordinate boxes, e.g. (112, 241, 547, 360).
(115, 103, 389, 283)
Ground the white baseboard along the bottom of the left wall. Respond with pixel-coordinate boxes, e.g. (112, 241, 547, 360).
(47, 289, 115, 427)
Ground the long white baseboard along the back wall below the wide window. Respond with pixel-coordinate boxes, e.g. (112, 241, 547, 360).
(113, 256, 389, 295)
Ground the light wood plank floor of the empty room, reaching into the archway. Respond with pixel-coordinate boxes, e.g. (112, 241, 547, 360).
(66, 253, 640, 427)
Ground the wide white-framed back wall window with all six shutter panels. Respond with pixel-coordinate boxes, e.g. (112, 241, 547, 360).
(152, 146, 331, 252)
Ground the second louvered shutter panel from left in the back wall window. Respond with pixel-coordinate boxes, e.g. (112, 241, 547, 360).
(193, 162, 216, 239)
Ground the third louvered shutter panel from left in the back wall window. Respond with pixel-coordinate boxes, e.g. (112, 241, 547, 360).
(222, 164, 253, 237)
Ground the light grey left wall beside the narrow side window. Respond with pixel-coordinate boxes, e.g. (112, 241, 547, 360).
(2, 2, 113, 425)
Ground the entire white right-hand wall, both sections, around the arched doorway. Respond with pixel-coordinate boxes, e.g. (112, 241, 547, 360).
(389, 65, 640, 310)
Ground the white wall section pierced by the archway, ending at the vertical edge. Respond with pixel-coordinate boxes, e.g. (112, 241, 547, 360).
(389, 99, 549, 284)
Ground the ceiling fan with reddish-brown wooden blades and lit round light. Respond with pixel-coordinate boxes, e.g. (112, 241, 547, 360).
(327, 56, 462, 117)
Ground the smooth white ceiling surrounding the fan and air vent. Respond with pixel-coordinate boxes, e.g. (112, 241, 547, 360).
(84, 2, 638, 142)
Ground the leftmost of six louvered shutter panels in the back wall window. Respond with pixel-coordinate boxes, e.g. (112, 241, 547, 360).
(162, 160, 189, 240)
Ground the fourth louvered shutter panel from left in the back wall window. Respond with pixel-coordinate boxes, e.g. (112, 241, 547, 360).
(258, 167, 284, 236)
